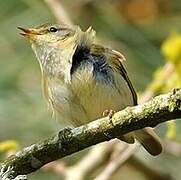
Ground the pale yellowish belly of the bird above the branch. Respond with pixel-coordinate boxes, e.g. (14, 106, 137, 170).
(48, 68, 133, 126)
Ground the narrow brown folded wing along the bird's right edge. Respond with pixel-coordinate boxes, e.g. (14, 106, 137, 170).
(91, 44, 137, 105)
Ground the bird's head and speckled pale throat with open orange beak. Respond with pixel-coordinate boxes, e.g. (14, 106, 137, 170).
(18, 24, 95, 78)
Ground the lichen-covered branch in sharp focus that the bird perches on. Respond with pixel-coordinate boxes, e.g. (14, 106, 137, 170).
(0, 89, 181, 180)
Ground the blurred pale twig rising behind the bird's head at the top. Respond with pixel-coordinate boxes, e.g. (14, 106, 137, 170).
(44, 0, 73, 25)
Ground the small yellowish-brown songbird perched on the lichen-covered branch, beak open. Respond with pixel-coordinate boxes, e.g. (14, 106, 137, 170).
(19, 23, 162, 155)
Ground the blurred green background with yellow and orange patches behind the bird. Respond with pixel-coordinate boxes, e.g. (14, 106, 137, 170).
(0, 0, 181, 180)
